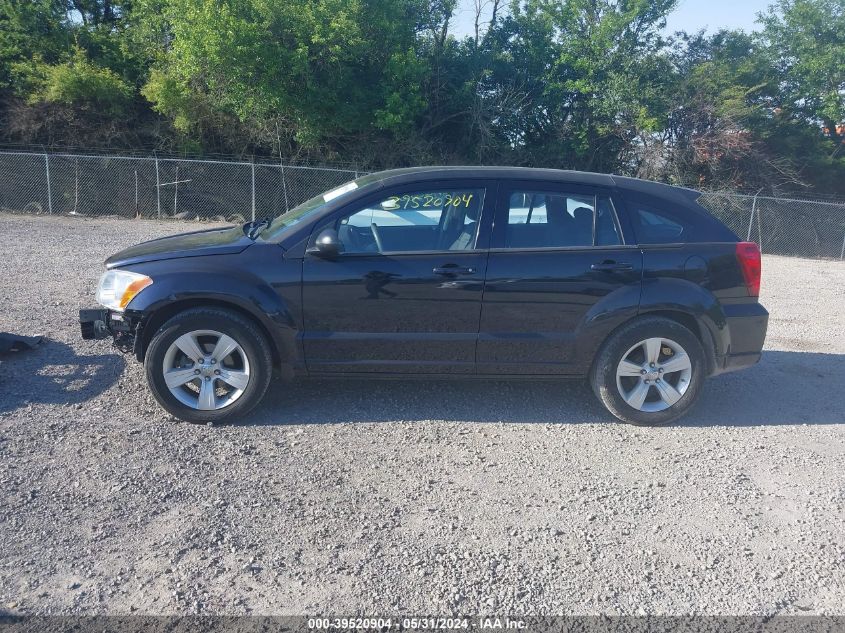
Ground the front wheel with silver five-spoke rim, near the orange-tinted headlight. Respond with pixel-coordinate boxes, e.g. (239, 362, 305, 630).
(144, 308, 273, 424)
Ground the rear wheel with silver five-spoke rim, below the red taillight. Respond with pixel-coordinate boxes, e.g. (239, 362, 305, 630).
(590, 317, 707, 426)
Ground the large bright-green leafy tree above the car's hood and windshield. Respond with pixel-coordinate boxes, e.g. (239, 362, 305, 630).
(144, 0, 425, 152)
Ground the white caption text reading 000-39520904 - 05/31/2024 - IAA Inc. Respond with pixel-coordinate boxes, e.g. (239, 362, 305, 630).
(308, 616, 527, 631)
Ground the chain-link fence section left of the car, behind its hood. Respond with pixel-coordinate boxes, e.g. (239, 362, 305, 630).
(0, 152, 360, 222)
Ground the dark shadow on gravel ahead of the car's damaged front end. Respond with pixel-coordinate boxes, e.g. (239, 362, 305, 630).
(0, 338, 126, 413)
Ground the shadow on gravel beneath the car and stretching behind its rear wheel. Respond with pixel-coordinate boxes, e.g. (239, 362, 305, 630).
(241, 351, 845, 426)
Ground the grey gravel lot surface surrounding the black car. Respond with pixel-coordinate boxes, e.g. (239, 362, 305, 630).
(0, 215, 845, 615)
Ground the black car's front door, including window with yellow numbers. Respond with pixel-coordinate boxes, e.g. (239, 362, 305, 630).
(302, 181, 495, 374)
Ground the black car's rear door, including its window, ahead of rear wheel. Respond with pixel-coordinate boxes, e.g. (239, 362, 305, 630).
(477, 181, 642, 374)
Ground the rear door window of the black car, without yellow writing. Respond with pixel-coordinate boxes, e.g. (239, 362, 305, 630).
(504, 191, 621, 249)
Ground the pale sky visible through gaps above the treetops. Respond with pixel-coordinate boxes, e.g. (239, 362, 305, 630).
(452, 0, 773, 37)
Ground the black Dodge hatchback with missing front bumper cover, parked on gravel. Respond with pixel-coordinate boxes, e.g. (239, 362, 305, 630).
(80, 167, 768, 424)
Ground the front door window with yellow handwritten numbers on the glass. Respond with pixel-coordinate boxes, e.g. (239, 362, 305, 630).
(324, 189, 484, 254)
